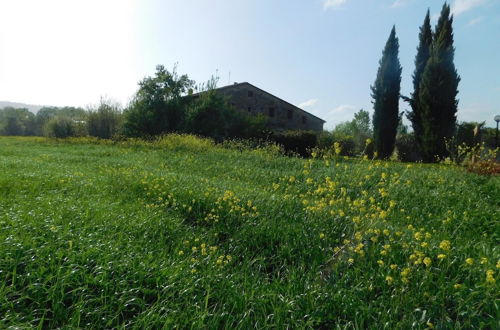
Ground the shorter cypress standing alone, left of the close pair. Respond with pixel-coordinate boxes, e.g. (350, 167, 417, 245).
(371, 27, 402, 159)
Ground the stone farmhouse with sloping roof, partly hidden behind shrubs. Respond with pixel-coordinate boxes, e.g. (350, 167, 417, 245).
(202, 82, 325, 132)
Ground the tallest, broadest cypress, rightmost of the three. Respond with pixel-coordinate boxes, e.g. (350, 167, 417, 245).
(418, 3, 460, 162)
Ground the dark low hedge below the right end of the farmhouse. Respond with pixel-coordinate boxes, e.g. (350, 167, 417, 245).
(271, 131, 318, 157)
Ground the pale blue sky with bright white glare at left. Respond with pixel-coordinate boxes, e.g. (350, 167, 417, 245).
(0, 0, 500, 128)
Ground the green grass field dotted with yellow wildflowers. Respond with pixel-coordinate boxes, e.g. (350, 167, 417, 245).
(0, 136, 500, 329)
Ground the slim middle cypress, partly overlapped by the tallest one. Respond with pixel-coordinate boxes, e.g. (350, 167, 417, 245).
(403, 10, 432, 153)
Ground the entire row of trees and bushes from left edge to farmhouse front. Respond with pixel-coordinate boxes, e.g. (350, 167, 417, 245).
(0, 65, 269, 141)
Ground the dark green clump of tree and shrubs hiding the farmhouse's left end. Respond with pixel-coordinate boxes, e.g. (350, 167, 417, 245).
(123, 65, 267, 141)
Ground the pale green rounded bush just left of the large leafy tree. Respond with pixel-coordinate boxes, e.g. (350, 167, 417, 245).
(87, 99, 123, 139)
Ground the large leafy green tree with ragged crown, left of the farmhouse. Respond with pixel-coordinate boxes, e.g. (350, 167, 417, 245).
(124, 65, 194, 136)
